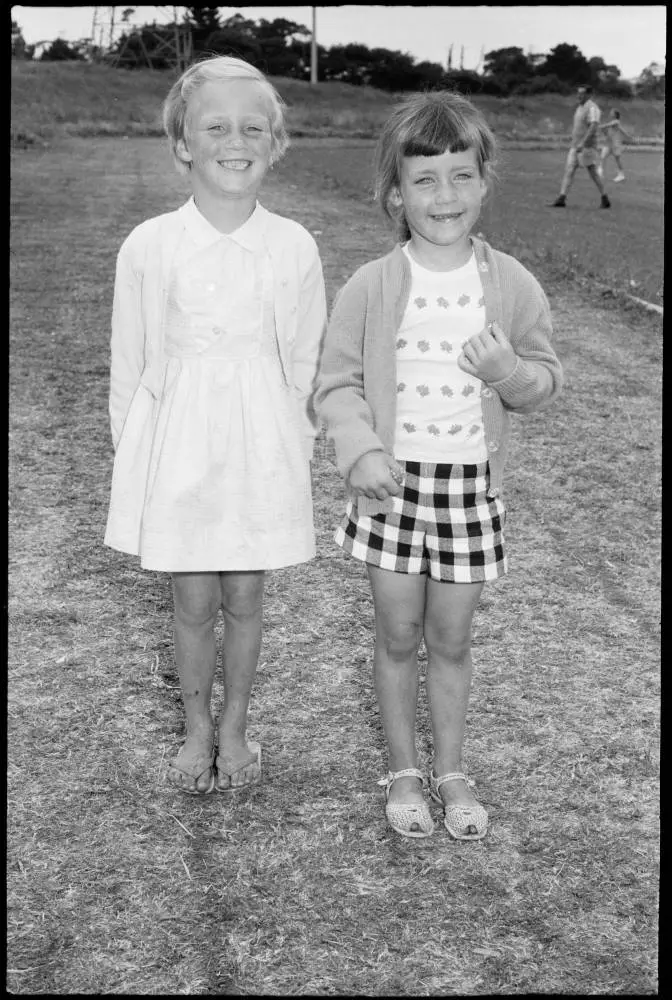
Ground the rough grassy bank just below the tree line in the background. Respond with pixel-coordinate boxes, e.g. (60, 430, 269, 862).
(11, 59, 665, 145)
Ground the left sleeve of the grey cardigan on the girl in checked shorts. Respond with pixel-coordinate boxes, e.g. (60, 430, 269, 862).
(315, 272, 385, 478)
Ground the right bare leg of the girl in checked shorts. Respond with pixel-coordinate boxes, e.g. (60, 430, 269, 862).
(424, 580, 483, 806)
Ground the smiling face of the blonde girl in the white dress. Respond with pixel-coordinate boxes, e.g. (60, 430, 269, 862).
(177, 79, 273, 199)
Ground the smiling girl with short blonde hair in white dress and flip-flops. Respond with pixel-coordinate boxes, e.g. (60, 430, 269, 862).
(105, 56, 326, 794)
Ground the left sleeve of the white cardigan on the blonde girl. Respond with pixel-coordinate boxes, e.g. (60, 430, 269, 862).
(109, 238, 145, 451)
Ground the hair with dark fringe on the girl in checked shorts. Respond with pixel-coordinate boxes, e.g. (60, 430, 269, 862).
(375, 90, 497, 242)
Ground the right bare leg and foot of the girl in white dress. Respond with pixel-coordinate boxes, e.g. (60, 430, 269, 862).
(218, 571, 264, 788)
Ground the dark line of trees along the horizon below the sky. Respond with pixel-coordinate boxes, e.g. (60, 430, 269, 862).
(12, 7, 665, 99)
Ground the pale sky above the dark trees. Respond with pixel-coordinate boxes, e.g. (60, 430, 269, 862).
(12, 4, 666, 79)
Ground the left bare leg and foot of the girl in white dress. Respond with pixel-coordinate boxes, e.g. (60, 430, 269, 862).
(168, 573, 221, 792)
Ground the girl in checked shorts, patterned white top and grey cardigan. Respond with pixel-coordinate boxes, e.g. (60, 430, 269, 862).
(316, 91, 562, 840)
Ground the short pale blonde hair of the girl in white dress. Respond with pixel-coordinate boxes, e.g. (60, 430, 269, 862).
(163, 56, 289, 173)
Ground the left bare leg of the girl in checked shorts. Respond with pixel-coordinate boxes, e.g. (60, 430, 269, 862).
(367, 566, 427, 805)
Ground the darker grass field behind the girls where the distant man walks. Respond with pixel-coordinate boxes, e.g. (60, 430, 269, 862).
(280, 139, 664, 305)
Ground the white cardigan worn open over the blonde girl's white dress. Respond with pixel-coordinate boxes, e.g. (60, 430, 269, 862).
(109, 199, 327, 455)
